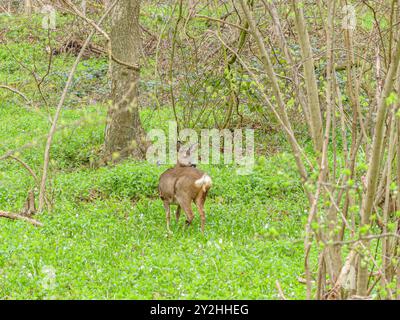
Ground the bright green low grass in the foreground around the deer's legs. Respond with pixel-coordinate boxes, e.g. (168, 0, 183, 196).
(0, 161, 304, 299)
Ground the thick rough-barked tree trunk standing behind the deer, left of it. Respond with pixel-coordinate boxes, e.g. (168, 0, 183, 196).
(105, 0, 145, 160)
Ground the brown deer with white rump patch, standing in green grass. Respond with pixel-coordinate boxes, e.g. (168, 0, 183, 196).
(158, 141, 212, 234)
